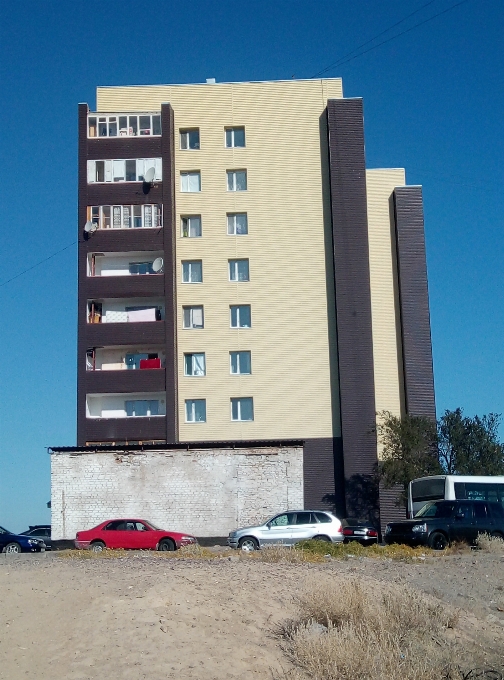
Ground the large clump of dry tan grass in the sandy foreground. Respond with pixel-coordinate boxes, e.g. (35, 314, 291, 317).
(279, 578, 461, 680)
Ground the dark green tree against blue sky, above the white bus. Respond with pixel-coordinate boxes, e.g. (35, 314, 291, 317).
(438, 408, 504, 475)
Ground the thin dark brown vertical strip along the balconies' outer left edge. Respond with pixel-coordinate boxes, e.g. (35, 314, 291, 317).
(77, 104, 89, 446)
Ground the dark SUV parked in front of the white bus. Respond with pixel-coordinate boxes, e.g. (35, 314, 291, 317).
(385, 500, 504, 550)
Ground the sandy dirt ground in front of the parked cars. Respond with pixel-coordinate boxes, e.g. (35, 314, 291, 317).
(0, 553, 504, 680)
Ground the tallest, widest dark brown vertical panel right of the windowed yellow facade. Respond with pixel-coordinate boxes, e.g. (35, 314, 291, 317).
(327, 99, 378, 512)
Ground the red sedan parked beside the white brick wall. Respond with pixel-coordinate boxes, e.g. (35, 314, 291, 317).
(75, 519, 198, 552)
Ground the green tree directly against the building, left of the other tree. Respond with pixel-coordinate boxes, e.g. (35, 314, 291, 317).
(377, 411, 443, 505)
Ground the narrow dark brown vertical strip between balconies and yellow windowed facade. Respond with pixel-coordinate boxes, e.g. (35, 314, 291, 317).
(161, 104, 178, 442)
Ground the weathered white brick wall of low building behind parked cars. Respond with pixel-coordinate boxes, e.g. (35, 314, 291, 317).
(51, 447, 303, 540)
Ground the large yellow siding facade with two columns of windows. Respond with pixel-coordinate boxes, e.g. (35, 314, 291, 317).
(97, 79, 342, 441)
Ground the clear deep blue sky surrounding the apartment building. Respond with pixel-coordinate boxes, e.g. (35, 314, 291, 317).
(0, 0, 504, 530)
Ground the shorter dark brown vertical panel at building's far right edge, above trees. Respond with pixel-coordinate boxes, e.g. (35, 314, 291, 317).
(394, 186, 436, 419)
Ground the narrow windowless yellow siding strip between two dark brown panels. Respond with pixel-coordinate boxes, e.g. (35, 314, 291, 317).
(366, 168, 405, 446)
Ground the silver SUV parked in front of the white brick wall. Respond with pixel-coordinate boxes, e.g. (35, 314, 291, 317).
(228, 510, 343, 551)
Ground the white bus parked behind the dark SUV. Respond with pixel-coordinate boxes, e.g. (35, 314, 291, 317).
(408, 475, 504, 518)
